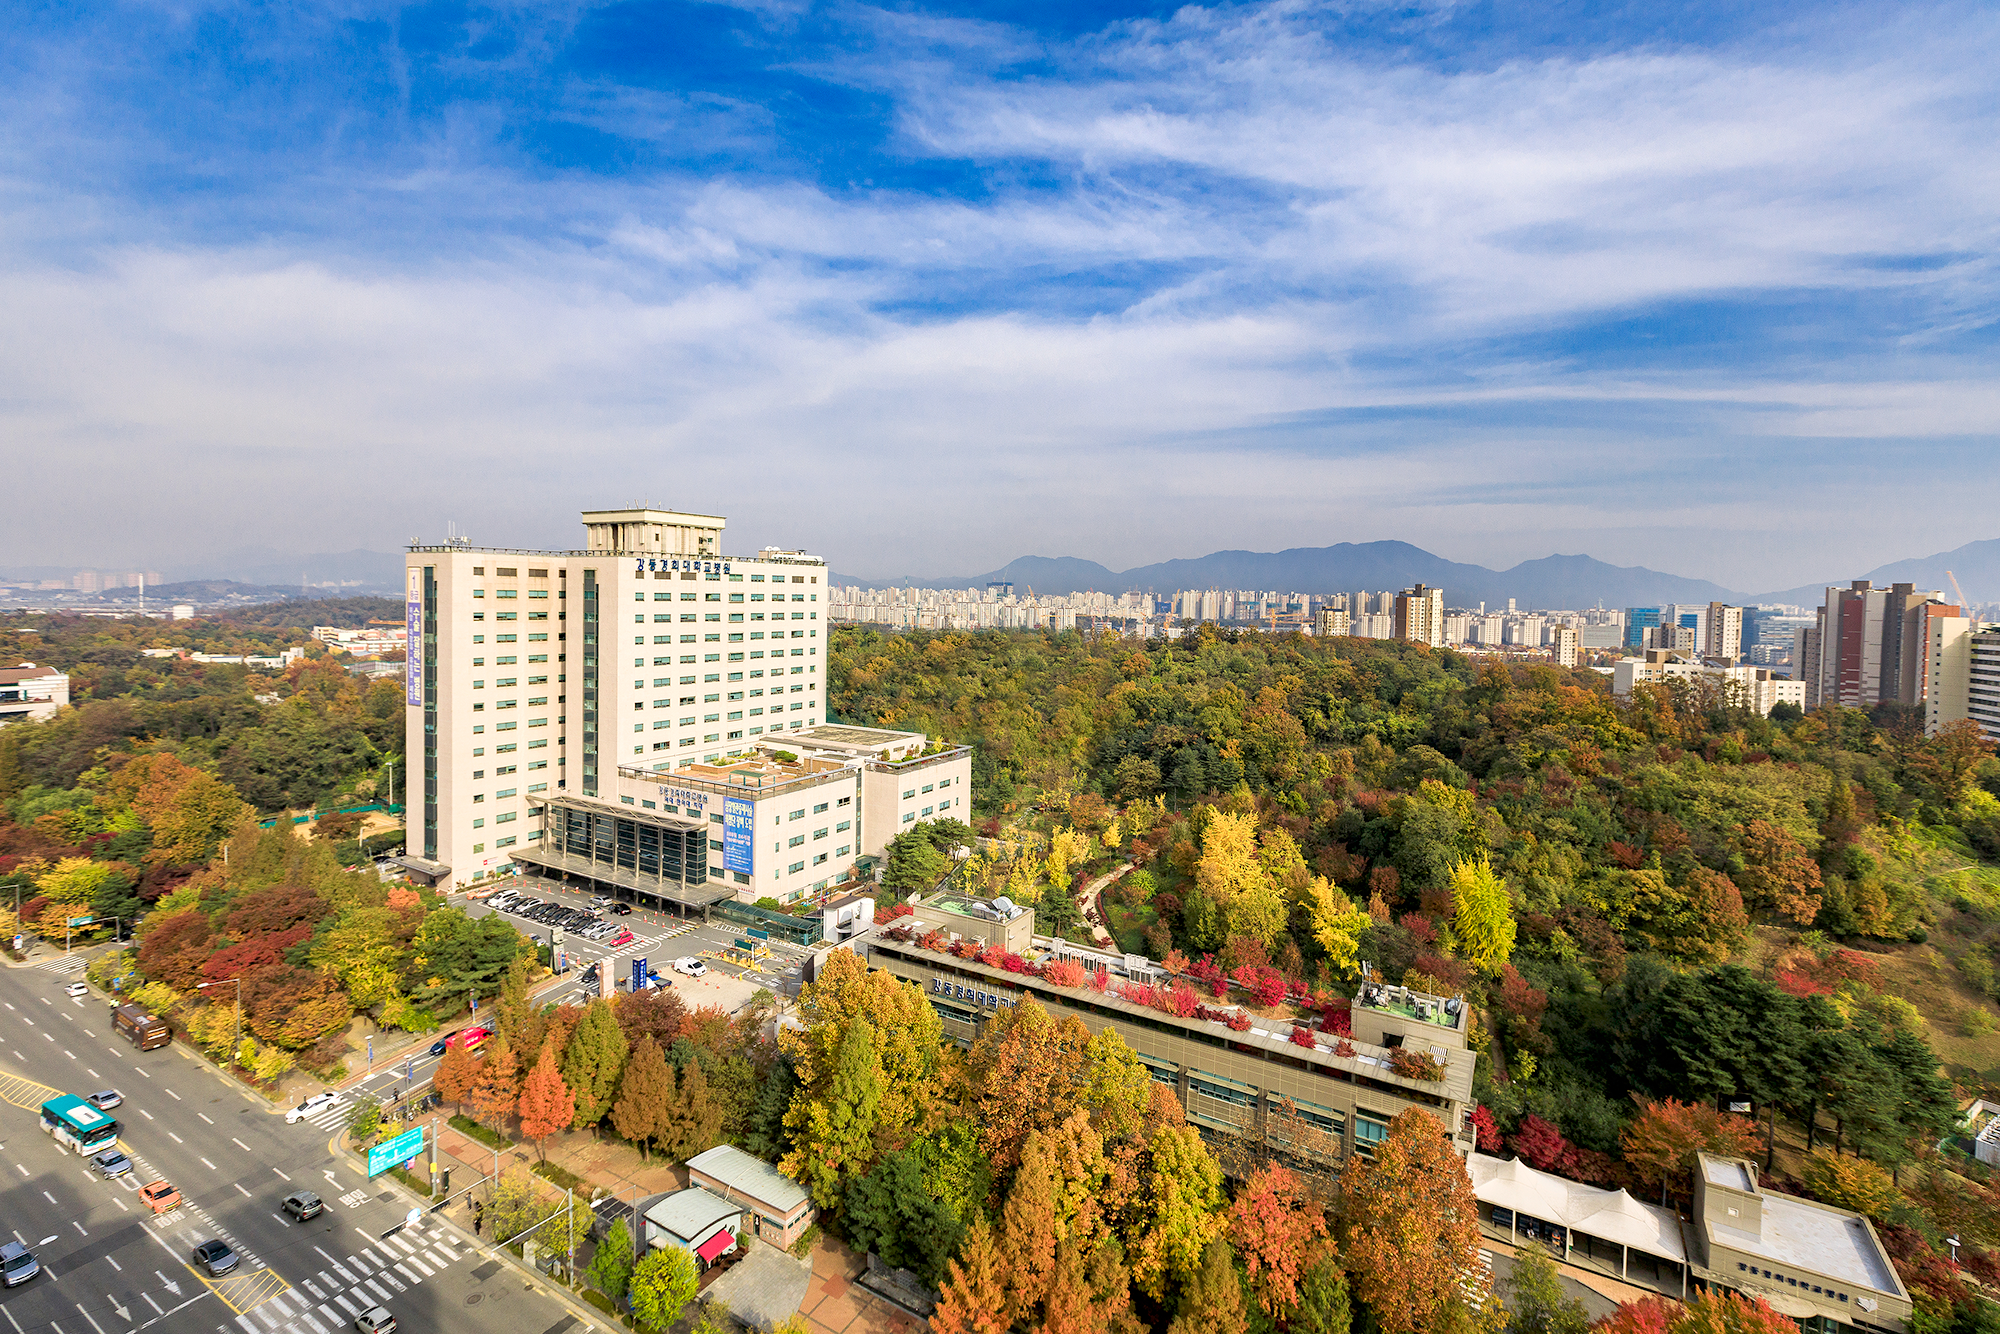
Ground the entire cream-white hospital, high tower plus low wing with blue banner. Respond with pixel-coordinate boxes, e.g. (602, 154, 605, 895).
(404, 508, 972, 906)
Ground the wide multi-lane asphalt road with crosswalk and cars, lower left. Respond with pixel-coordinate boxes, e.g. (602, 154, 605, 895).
(0, 968, 580, 1334)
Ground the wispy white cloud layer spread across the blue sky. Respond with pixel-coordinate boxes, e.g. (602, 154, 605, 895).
(0, 4, 2000, 586)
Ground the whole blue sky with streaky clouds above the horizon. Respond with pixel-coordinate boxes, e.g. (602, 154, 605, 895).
(0, 2, 2000, 588)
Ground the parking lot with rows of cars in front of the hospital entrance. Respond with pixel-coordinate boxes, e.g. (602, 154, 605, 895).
(466, 876, 806, 1010)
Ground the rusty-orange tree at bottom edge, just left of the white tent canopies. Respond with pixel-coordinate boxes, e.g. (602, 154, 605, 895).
(1340, 1108, 1494, 1334)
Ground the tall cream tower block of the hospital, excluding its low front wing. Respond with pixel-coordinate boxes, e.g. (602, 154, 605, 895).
(404, 508, 826, 882)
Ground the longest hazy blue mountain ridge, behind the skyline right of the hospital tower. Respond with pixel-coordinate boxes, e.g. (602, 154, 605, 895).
(828, 542, 1742, 608)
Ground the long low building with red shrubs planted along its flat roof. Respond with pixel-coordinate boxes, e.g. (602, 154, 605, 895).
(868, 892, 1474, 1156)
